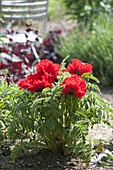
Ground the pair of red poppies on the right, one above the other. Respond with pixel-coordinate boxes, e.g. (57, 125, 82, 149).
(62, 58, 93, 99)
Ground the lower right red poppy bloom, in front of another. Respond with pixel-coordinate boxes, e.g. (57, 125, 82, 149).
(61, 74, 86, 99)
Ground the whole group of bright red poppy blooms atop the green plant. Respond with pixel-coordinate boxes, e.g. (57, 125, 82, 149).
(18, 59, 93, 99)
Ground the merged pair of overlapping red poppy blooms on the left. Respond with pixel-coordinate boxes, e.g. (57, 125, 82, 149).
(18, 59, 60, 92)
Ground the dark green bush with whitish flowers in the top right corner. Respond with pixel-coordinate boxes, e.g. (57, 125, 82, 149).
(64, 0, 113, 28)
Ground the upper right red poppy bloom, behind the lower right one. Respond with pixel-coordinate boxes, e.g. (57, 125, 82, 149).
(68, 58, 93, 75)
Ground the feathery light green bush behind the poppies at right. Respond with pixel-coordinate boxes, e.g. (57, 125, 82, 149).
(57, 17, 113, 85)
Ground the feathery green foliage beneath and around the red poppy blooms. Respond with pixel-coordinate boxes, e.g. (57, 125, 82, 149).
(0, 58, 112, 162)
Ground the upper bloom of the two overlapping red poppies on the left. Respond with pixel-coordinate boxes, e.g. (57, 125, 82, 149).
(36, 59, 60, 82)
